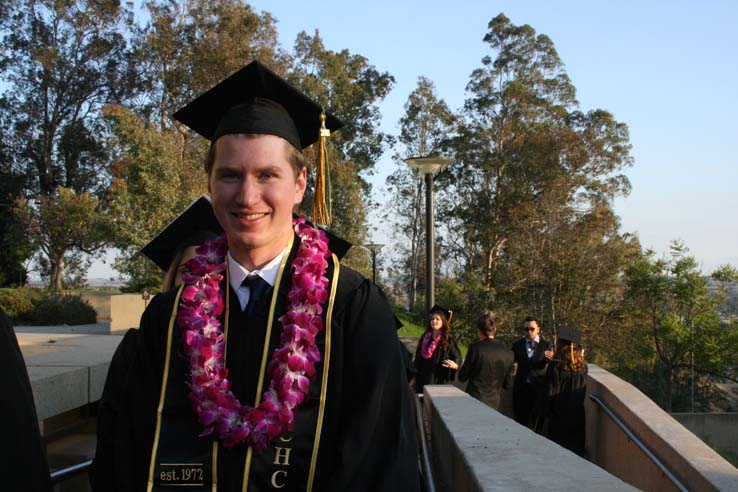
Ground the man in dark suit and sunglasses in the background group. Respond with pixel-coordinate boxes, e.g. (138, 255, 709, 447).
(512, 316, 553, 433)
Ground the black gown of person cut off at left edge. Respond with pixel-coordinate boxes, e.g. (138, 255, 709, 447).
(0, 309, 51, 492)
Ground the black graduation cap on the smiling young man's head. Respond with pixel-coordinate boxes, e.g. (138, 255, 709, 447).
(174, 61, 343, 150)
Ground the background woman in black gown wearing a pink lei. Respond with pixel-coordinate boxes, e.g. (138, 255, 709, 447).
(408, 305, 461, 393)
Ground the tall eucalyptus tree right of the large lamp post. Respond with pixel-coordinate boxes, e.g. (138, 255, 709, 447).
(438, 14, 638, 344)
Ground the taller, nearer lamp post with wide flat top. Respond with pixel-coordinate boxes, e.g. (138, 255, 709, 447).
(405, 156, 453, 321)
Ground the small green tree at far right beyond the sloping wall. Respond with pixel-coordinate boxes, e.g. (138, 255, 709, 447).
(626, 242, 738, 411)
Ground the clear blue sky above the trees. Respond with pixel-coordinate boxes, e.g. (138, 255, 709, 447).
(90, 0, 738, 276)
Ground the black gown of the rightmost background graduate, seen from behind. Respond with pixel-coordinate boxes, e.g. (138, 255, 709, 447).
(539, 362, 587, 456)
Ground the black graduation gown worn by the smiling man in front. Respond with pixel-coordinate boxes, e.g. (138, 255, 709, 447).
(90, 240, 419, 492)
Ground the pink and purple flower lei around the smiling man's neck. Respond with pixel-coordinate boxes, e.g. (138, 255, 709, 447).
(177, 217, 331, 451)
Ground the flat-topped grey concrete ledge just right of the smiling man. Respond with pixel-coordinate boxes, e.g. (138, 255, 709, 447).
(423, 386, 635, 492)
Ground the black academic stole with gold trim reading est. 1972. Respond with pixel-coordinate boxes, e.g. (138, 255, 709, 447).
(147, 244, 340, 492)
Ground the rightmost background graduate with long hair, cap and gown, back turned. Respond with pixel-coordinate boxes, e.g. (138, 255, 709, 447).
(537, 326, 587, 457)
